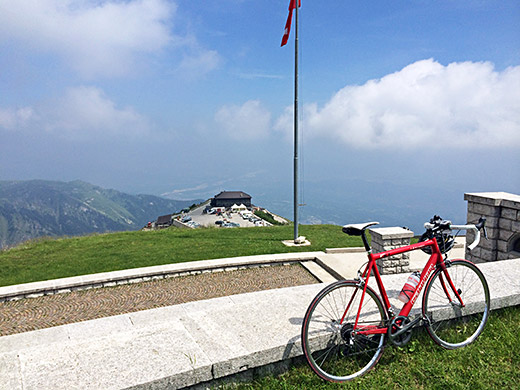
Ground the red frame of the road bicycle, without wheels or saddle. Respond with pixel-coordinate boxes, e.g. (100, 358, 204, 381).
(350, 233, 464, 335)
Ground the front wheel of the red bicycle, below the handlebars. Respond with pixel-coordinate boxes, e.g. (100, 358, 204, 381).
(422, 260, 490, 349)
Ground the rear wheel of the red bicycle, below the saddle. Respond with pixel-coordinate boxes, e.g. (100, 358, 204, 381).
(302, 280, 387, 382)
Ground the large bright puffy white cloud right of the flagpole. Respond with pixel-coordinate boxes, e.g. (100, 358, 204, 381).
(275, 59, 520, 150)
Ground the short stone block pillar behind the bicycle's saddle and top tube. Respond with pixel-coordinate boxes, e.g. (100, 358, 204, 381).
(370, 227, 413, 275)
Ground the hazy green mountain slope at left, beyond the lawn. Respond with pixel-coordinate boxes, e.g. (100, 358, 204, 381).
(0, 180, 197, 248)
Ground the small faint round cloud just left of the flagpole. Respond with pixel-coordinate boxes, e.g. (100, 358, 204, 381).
(215, 100, 271, 140)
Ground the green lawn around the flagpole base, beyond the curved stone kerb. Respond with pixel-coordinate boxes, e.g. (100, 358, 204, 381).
(0, 225, 362, 286)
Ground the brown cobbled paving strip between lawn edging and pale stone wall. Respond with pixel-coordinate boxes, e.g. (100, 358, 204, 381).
(0, 264, 318, 336)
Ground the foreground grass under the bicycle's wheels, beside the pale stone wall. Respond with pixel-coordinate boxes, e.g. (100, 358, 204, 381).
(221, 306, 520, 390)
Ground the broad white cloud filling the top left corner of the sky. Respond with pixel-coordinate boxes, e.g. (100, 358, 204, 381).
(0, 0, 214, 78)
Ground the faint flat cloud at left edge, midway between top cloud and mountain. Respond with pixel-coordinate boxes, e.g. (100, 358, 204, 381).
(0, 86, 150, 139)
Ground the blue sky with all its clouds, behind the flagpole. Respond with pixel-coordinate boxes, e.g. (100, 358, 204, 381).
(0, 0, 520, 229)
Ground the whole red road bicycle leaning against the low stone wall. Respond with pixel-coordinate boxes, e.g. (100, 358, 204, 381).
(301, 216, 490, 382)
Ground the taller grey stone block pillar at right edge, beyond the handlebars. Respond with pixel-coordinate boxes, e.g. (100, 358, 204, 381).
(464, 192, 520, 263)
